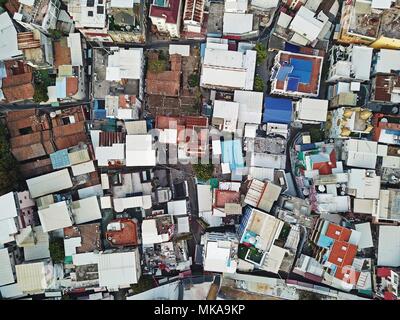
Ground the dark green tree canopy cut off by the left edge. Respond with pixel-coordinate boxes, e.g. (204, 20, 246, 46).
(0, 122, 21, 195)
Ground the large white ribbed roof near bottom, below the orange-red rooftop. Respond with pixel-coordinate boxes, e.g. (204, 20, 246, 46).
(98, 248, 141, 291)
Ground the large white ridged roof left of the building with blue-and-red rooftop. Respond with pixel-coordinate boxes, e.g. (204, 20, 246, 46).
(200, 40, 257, 91)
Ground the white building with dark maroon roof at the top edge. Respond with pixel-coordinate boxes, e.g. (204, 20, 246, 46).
(149, 0, 182, 38)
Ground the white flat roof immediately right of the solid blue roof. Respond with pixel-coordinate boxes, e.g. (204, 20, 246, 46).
(294, 98, 329, 124)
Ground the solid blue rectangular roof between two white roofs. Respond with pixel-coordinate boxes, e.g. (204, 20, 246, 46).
(263, 97, 292, 124)
